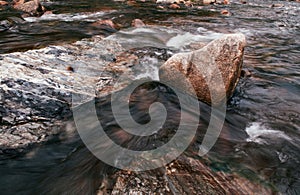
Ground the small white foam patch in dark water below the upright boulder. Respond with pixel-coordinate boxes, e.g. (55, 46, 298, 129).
(246, 122, 292, 144)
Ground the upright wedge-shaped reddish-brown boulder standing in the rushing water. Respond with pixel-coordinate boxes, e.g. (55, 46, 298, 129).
(159, 34, 246, 104)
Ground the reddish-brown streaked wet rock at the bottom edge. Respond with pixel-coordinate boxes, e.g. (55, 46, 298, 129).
(111, 155, 272, 194)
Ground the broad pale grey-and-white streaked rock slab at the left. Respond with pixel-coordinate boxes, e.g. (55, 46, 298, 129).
(0, 37, 133, 153)
